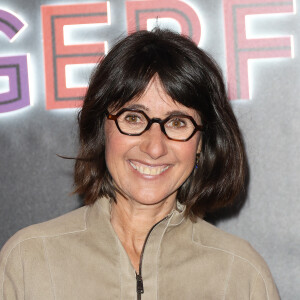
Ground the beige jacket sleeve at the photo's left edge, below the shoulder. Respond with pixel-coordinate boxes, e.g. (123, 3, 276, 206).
(0, 242, 24, 300)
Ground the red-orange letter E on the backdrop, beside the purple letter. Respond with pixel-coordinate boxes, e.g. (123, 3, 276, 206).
(41, 2, 109, 109)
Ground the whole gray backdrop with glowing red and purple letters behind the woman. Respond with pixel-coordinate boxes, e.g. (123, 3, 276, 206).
(0, 0, 300, 300)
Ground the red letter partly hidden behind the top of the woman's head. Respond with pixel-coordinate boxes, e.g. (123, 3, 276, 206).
(126, 0, 201, 45)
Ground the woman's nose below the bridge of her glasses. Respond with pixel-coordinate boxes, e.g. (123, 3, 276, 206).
(140, 123, 168, 159)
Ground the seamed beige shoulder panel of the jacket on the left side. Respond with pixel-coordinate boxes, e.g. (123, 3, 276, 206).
(0, 206, 88, 259)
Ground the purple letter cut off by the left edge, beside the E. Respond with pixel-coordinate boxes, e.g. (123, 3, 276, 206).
(0, 9, 30, 113)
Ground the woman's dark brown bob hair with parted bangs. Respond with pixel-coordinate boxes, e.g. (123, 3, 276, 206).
(75, 28, 246, 220)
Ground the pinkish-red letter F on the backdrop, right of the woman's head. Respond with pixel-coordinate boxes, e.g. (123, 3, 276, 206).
(223, 0, 293, 99)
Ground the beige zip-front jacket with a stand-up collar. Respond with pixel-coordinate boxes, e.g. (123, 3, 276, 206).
(0, 199, 279, 300)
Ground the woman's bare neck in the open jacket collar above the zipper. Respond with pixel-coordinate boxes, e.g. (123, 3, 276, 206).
(111, 197, 176, 272)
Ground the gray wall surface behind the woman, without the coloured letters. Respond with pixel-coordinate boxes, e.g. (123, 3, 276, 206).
(0, 0, 300, 300)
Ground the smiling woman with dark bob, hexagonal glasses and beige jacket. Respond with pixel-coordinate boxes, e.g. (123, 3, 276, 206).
(0, 29, 279, 300)
